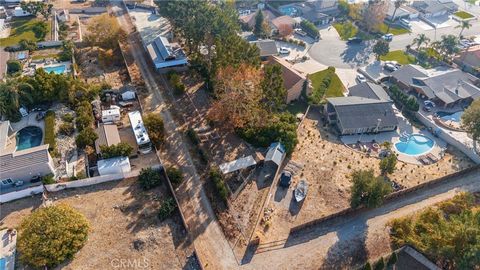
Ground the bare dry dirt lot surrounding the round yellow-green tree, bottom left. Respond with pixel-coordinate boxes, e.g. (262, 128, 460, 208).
(1, 179, 198, 269)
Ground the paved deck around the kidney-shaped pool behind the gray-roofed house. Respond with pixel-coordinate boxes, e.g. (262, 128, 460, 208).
(340, 106, 447, 165)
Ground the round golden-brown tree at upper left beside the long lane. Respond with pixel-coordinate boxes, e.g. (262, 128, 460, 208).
(85, 13, 125, 49)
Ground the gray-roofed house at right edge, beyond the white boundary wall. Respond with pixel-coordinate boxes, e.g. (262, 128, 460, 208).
(392, 65, 480, 107)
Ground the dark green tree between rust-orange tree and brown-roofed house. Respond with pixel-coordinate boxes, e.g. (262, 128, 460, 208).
(260, 64, 287, 112)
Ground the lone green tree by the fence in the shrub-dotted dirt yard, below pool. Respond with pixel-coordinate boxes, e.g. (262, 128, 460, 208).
(350, 170, 392, 208)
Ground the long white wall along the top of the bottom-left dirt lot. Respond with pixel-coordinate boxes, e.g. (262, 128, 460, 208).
(0, 170, 139, 203)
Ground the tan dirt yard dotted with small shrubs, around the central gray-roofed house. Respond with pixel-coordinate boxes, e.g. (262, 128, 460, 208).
(263, 110, 473, 241)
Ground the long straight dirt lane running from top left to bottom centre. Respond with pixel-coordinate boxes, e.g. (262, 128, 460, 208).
(109, 2, 238, 269)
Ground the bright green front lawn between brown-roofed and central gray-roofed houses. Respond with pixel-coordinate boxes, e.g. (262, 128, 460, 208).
(308, 68, 345, 101)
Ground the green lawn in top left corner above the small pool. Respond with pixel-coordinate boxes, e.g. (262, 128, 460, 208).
(0, 17, 51, 47)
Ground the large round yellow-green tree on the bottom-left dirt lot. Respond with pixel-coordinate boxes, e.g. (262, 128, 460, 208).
(17, 204, 90, 269)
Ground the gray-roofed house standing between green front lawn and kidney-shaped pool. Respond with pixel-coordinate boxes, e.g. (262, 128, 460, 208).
(324, 82, 398, 135)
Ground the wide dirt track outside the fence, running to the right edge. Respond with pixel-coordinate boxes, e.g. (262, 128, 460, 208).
(242, 168, 480, 269)
